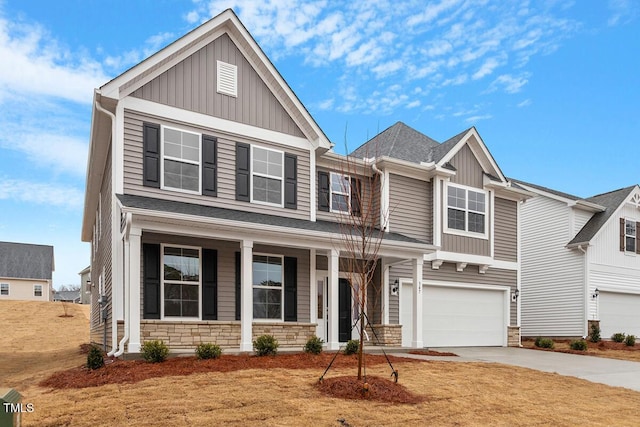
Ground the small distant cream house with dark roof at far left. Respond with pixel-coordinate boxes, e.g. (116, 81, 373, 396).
(0, 242, 55, 301)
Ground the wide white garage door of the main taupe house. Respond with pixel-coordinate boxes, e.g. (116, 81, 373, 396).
(400, 284, 507, 347)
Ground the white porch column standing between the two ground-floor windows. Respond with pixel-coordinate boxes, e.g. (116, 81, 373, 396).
(240, 240, 253, 351)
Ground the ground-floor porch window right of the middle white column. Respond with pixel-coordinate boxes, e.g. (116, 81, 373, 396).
(253, 254, 284, 320)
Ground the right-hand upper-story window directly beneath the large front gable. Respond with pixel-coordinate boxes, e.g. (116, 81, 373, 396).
(251, 146, 284, 206)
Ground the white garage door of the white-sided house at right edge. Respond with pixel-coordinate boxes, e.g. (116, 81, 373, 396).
(598, 292, 640, 339)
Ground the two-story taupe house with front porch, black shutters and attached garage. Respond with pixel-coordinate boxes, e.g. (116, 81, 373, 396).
(82, 10, 528, 355)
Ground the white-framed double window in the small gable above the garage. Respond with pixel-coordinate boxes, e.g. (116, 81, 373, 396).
(447, 185, 487, 237)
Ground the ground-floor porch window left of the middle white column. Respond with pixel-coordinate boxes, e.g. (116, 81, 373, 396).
(162, 246, 200, 318)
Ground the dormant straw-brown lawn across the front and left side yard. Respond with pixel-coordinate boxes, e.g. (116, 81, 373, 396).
(0, 301, 640, 426)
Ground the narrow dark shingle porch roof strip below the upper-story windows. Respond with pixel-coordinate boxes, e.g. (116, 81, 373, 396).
(117, 194, 427, 244)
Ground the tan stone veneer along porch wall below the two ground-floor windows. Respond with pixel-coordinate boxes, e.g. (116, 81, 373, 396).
(140, 320, 316, 350)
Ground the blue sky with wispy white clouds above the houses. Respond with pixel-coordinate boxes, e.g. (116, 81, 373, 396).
(0, 0, 640, 287)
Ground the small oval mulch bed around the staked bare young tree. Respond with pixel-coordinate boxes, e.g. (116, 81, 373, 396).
(316, 375, 425, 404)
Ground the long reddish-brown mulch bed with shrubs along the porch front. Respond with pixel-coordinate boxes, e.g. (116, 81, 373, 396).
(39, 353, 428, 389)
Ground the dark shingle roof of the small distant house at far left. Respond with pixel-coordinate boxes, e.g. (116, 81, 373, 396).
(0, 242, 54, 280)
